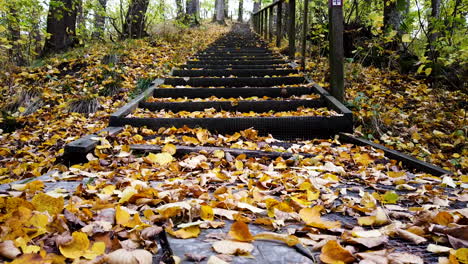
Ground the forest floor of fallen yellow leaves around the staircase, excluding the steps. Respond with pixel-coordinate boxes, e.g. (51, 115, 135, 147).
(0, 22, 468, 263)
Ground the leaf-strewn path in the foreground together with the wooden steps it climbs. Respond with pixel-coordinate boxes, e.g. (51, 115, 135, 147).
(0, 23, 468, 263)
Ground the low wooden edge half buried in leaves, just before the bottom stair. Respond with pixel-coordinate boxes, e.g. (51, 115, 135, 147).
(130, 144, 316, 159)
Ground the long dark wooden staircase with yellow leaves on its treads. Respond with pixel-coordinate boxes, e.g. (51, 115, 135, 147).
(110, 25, 352, 139)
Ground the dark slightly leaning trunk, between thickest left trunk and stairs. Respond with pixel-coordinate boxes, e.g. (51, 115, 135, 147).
(122, 0, 149, 38)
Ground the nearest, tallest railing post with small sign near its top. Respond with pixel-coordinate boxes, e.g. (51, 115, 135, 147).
(329, 0, 344, 102)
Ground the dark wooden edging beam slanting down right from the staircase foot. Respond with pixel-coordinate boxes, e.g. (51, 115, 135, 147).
(339, 133, 452, 176)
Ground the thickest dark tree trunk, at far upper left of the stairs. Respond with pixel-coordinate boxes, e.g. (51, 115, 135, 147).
(42, 0, 77, 56)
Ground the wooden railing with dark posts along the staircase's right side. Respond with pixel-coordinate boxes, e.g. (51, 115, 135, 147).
(252, 0, 344, 102)
